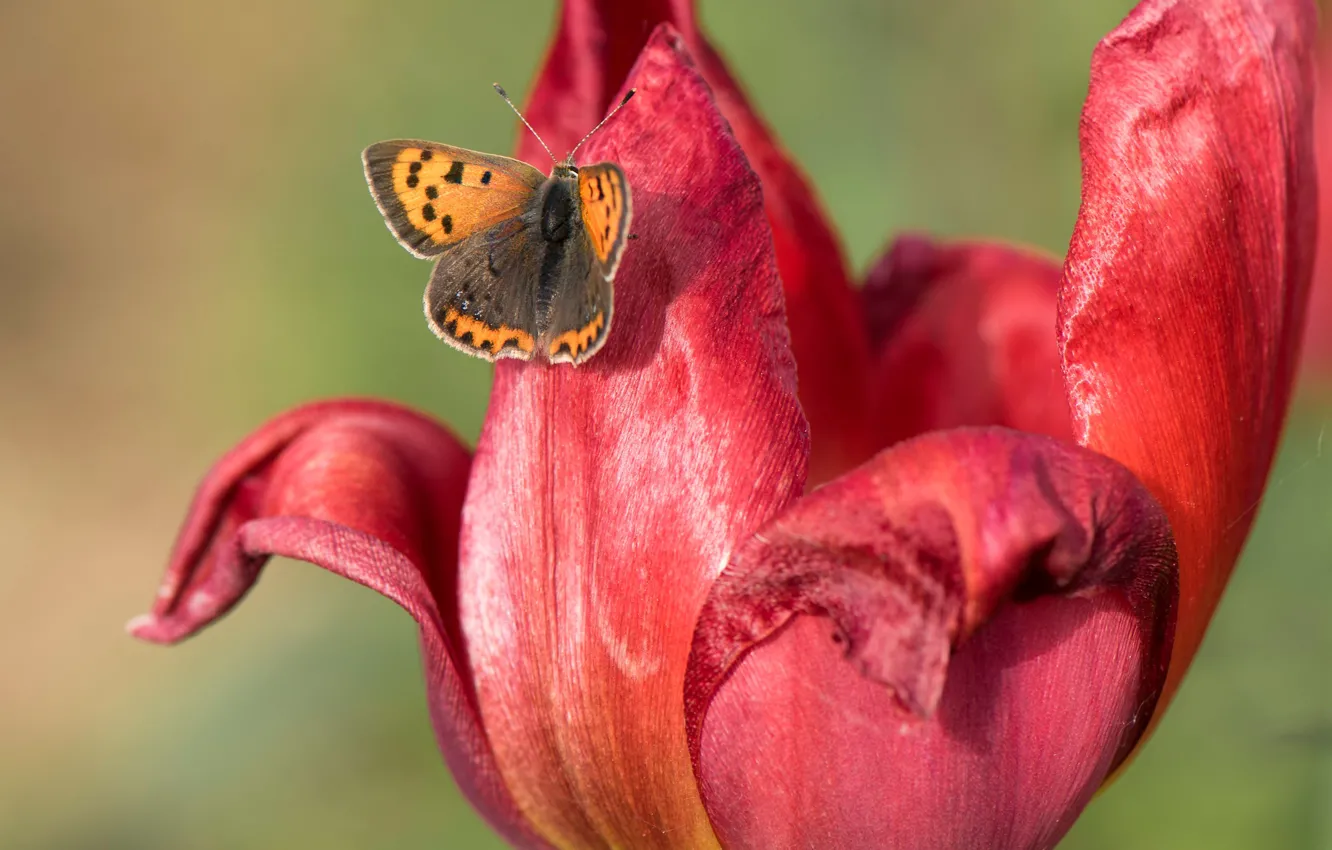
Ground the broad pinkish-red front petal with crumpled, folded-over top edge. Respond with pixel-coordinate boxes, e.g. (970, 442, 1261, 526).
(685, 429, 1177, 849)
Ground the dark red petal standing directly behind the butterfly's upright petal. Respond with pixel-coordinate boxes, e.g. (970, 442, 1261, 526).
(518, 0, 882, 481)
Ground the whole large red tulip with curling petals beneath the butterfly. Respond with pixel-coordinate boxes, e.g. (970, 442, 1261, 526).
(133, 0, 1315, 847)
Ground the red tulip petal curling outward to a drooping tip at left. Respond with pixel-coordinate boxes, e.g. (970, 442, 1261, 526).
(129, 401, 546, 847)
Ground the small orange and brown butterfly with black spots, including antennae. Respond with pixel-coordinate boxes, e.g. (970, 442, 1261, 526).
(361, 84, 634, 365)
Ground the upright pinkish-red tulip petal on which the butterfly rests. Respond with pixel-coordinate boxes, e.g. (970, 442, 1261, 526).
(460, 27, 809, 847)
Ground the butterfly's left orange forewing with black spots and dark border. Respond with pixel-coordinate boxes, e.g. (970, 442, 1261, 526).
(361, 139, 546, 258)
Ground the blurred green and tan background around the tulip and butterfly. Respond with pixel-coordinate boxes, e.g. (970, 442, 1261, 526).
(0, 0, 1332, 850)
